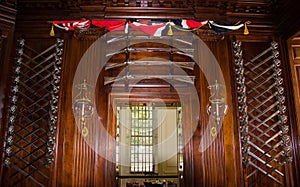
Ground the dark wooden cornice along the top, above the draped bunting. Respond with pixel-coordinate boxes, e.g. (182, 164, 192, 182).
(0, 0, 300, 38)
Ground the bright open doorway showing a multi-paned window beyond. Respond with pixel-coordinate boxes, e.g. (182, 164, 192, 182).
(116, 102, 184, 187)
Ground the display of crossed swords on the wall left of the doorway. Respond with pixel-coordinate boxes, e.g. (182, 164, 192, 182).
(4, 39, 63, 186)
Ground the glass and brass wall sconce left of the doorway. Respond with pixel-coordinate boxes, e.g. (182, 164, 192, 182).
(73, 80, 94, 137)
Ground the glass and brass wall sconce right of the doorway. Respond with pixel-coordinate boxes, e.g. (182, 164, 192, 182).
(207, 80, 228, 137)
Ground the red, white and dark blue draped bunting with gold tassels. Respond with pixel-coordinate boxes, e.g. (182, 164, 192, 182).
(53, 19, 247, 36)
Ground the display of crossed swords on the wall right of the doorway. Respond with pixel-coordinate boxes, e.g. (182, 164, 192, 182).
(233, 41, 292, 186)
